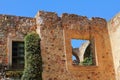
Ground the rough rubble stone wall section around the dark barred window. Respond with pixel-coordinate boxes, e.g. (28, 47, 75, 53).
(0, 15, 36, 64)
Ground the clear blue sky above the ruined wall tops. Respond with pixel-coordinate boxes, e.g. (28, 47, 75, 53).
(0, 0, 120, 20)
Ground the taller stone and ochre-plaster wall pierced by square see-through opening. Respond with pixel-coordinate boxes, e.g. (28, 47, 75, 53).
(36, 11, 115, 80)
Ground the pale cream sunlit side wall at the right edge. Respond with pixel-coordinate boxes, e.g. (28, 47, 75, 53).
(108, 13, 120, 80)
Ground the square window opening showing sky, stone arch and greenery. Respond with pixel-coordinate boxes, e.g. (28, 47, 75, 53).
(71, 39, 95, 66)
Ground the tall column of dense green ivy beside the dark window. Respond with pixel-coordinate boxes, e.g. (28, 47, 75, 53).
(21, 32, 42, 80)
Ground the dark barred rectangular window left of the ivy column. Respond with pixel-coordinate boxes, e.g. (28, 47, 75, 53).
(12, 41, 24, 69)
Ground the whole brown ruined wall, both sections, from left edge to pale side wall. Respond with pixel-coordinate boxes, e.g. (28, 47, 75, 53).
(0, 11, 115, 80)
